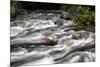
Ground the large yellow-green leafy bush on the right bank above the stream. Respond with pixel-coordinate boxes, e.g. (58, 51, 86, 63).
(74, 6, 95, 26)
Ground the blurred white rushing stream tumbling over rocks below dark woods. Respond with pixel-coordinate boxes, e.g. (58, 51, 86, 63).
(10, 10, 95, 67)
